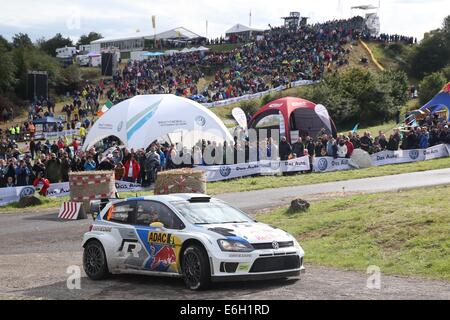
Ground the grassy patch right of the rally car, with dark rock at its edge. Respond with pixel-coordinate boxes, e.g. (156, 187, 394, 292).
(257, 186, 450, 280)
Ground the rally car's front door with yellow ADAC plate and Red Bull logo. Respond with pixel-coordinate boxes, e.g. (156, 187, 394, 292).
(135, 200, 184, 273)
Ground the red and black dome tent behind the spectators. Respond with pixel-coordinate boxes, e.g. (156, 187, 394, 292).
(249, 97, 336, 141)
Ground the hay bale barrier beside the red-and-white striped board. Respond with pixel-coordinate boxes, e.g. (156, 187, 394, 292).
(69, 171, 116, 213)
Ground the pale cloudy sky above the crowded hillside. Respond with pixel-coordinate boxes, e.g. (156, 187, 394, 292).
(0, 0, 450, 41)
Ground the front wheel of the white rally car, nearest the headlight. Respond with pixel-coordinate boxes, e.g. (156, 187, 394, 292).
(181, 244, 211, 290)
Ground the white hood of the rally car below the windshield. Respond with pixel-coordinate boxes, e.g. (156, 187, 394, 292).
(202, 222, 293, 243)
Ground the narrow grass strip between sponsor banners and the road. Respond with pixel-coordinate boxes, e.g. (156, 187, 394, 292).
(207, 158, 450, 194)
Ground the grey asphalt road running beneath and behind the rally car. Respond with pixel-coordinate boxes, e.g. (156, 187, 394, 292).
(0, 169, 450, 300)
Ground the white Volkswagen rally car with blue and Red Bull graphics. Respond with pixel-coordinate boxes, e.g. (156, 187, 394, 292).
(83, 194, 304, 290)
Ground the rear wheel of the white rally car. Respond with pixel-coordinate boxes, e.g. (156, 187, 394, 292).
(83, 240, 109, 280)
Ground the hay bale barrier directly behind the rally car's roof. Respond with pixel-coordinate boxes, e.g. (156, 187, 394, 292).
(155, 168, 206, 195)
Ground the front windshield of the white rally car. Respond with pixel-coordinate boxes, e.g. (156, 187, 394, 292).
(172, 200, 253, 224)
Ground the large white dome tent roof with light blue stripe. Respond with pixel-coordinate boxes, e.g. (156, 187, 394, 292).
(83, 94, 233, 150)
